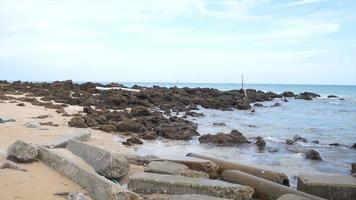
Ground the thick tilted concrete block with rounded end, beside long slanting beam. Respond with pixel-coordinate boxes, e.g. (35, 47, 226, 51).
(66, 140, 129, 179)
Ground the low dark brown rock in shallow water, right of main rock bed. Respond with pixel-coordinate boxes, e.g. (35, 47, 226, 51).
(198, 130, 248, 146)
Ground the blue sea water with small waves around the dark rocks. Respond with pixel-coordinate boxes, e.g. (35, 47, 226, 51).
(115, 83, 356, 186)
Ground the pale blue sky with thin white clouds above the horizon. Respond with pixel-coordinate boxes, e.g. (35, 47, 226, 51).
(0, 0, 356, 85)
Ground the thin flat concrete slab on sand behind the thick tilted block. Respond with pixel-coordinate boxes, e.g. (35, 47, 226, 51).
(43, 130, 91, 148)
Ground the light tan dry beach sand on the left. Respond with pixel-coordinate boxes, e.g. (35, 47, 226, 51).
(0, 96, 139, 200)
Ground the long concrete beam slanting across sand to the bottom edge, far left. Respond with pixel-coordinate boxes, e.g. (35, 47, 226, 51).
(39, 146, 139, 200)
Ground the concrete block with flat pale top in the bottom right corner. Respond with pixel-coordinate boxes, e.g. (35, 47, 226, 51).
(297, 175, 356, 200)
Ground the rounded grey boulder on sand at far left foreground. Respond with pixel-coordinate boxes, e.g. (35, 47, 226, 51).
(7, 140, 38, 162)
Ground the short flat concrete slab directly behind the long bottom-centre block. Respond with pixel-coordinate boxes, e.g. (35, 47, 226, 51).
(144, 161, 209, 178)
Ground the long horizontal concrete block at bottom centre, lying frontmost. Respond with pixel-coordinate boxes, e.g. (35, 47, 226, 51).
(128, 172, 253, 200)
